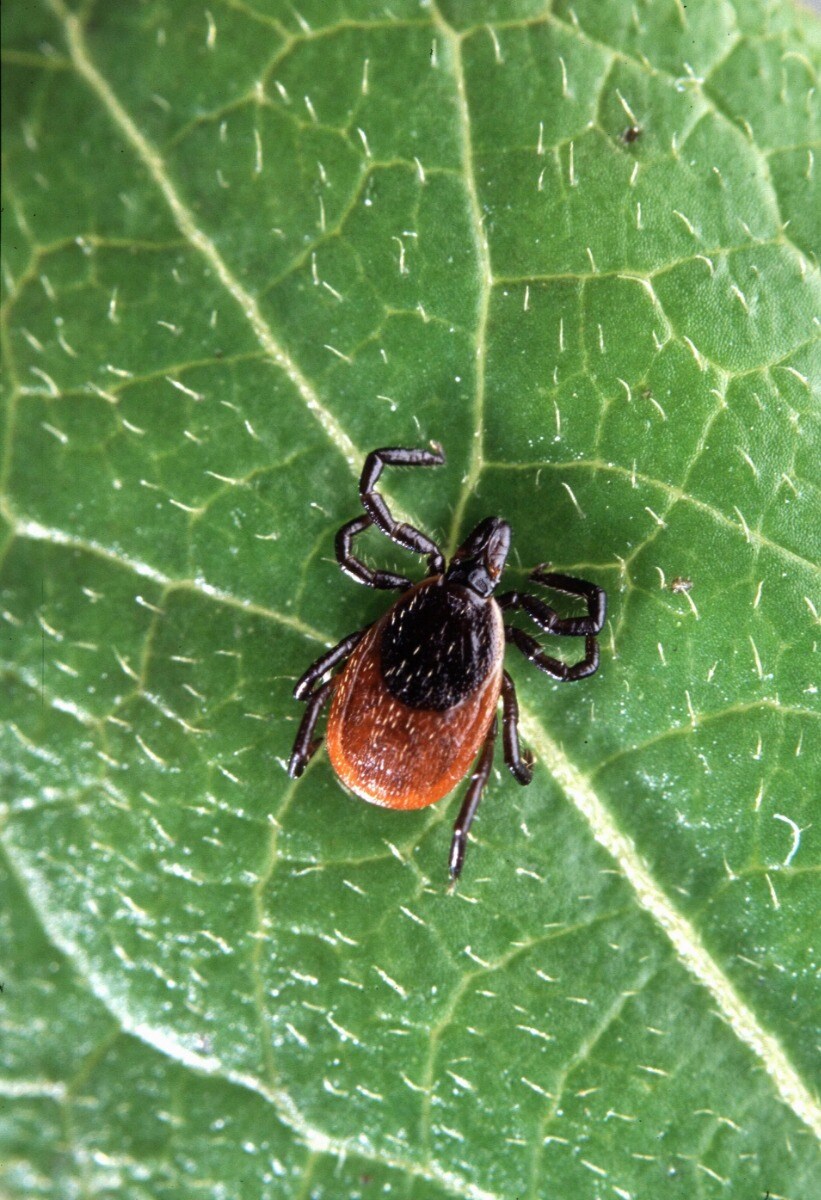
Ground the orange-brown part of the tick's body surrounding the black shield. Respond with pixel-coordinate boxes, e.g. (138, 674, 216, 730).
(326, 577, 504, 809)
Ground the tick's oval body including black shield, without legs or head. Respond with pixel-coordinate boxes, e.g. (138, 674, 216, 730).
(328, 575, 504, 809)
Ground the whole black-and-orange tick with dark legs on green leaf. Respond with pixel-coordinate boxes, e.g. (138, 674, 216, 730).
(288, 443, 606, 880)
